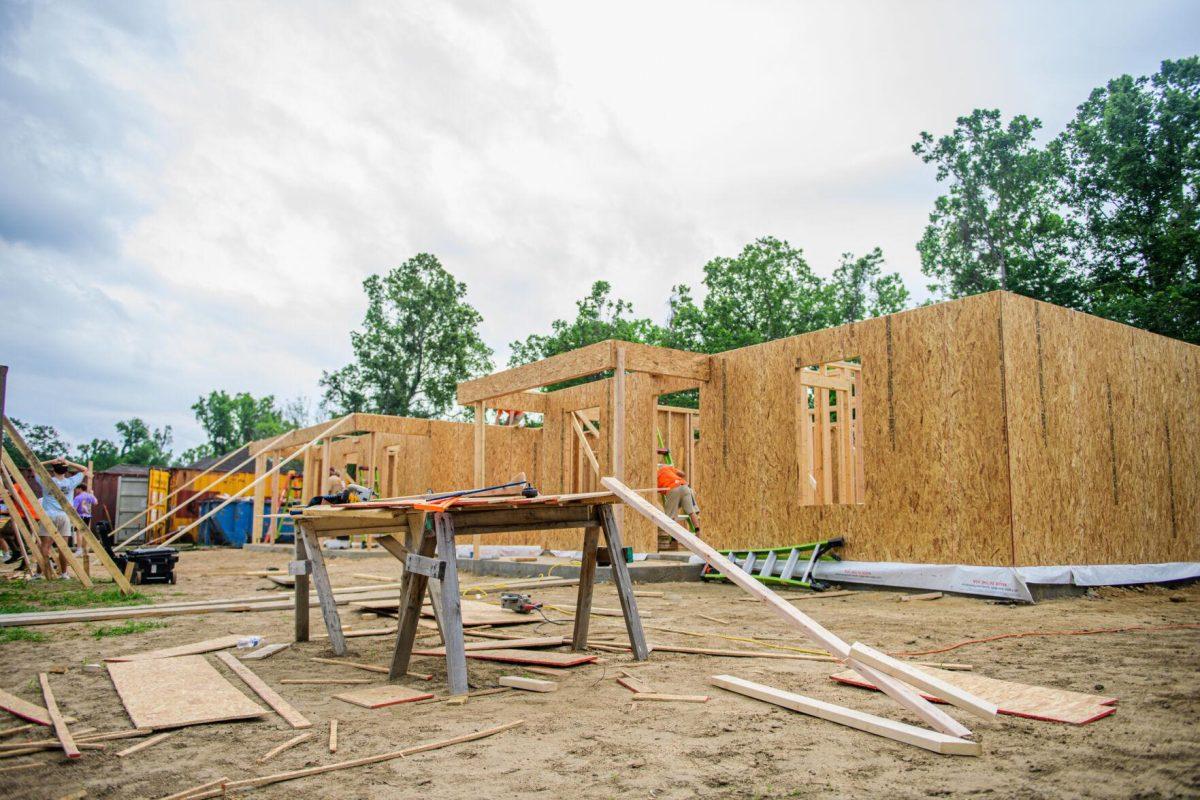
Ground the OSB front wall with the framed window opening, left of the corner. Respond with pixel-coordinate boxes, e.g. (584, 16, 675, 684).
(700, 294, 1012, 564)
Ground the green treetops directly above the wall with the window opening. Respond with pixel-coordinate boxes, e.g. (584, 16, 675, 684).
(664, 236, 908, 353)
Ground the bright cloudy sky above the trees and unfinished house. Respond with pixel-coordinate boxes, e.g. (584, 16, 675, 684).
(7, 0, 1200, 450)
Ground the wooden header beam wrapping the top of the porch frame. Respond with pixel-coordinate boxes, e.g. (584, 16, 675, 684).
(458, 339, 710, 410)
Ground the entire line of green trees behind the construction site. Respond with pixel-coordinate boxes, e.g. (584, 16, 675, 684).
(11, 56, 1200, 464)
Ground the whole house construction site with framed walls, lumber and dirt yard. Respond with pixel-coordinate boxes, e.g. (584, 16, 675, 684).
(0, 291, 1200, 800)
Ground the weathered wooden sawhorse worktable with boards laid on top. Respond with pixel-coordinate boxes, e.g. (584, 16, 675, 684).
(289, 493, 649, 694)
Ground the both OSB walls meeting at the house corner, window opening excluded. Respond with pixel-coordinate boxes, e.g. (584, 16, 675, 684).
(700, 293, 1200, 566)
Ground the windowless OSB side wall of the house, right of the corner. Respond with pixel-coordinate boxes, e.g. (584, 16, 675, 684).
(1002, 295, 1200, 565)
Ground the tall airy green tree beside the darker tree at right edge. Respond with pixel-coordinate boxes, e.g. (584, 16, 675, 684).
(912, 109, 1081, 307)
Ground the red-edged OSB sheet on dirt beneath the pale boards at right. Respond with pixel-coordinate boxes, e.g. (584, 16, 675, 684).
(830, 669, 1117, 724)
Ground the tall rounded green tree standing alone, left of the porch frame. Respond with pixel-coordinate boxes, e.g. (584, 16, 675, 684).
(320, 253, 492, 417)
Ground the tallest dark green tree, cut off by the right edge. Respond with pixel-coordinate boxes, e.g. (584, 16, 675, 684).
(1054, 56, 1200, 343)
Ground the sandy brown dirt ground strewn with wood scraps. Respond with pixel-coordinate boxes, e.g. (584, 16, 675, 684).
(0, 551, 1200, 800)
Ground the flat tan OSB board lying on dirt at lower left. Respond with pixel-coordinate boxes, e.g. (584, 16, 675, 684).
(107, 656, 268, 728)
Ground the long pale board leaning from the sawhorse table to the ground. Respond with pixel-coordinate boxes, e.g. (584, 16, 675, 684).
(609, 477, 971, 738)
